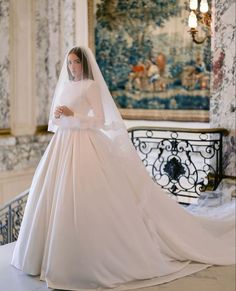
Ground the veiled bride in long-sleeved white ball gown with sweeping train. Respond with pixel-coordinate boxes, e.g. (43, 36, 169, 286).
(12, 47, 235, 290)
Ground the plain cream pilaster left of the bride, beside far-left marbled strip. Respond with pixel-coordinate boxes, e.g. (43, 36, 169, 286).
(10, 0, 36, 135)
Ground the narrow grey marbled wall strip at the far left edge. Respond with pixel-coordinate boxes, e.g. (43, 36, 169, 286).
(0, 0, 10, 128)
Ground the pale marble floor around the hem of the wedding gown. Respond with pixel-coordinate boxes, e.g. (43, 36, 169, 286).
(0, 243, 236, 291)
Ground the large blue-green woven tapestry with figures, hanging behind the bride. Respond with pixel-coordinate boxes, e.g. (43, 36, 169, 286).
(88, 0, 211, 121)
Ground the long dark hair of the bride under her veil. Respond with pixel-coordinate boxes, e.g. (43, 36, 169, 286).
(67, 47, 93, 80)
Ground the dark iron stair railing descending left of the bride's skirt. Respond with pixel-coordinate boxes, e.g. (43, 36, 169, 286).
(0, 190, 29, 245)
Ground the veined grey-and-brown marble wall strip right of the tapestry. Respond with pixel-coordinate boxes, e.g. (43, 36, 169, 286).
(210, 0, 236, 176)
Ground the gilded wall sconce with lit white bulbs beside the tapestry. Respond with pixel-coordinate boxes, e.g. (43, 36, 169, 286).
(188, 0, 211, 44)
